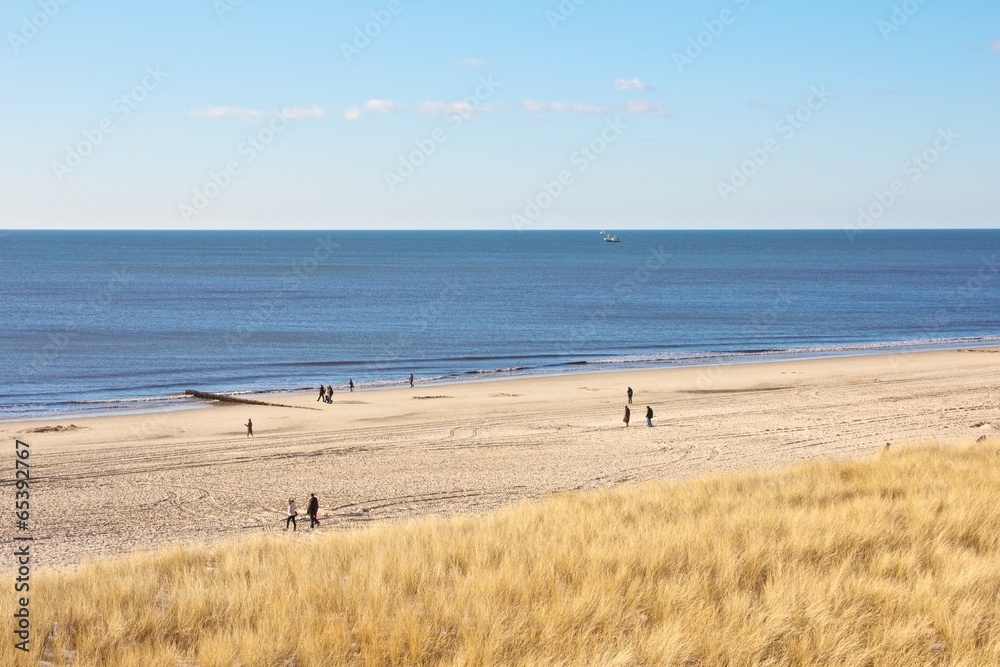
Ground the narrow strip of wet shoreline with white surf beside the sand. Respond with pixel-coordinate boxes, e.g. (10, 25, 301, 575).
(0, 336, 1000, 425)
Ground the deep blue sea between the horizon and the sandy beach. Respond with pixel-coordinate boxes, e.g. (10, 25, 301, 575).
(0, 230, 1000, 419)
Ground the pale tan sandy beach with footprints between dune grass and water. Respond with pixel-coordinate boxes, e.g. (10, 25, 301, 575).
(0, 349, 1000, 565)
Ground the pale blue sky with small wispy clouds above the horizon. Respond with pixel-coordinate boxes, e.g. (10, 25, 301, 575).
(0, 0, 1000, 229)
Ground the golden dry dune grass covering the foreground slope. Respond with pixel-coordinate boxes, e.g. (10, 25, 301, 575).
(0, 443, 1000, 667)
